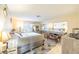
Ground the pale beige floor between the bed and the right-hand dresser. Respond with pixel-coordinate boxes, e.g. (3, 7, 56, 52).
(26, 41, 62, 54)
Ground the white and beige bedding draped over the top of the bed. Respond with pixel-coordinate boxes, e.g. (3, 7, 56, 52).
(18, 32, 44, 46)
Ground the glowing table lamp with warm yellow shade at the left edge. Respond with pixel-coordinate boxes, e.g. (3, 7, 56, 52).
(0, 32, 10, 53)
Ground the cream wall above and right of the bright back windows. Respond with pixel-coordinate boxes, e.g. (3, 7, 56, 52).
(50, 13, 79, 33)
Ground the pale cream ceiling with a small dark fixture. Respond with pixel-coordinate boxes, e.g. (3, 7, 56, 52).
(7, 4, 79, 21)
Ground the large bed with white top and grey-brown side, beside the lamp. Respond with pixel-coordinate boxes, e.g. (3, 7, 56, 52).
(8, 32, 44, 54)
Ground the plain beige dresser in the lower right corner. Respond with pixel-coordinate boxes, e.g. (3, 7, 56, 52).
(62, 35, 79, 54)
